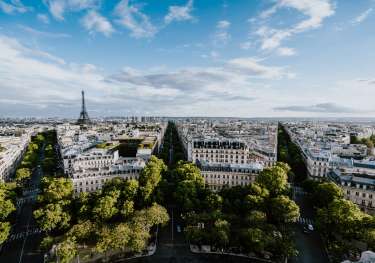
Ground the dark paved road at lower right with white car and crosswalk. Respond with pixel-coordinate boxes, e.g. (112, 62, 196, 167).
(291, 188, 329, 263)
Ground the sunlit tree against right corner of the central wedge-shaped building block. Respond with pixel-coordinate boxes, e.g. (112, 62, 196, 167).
(256, 165, 288, 196)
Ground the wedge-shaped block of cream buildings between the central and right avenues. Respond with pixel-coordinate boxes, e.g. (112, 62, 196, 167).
(177, 120, 277, 190)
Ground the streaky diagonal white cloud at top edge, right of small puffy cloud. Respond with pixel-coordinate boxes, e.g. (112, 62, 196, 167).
(115, 0, 158, 38)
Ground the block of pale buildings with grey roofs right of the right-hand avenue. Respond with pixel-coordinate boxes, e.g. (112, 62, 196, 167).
(284, 122, 375, 213)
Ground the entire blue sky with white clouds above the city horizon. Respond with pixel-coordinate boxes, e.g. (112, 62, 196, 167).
(0, 0, 375, 117)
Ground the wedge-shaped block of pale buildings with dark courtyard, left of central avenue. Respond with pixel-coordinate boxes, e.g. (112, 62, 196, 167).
(57, 123, 166, 194)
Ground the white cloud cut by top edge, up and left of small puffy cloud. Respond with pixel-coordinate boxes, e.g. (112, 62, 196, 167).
(43, 0, 101, 20)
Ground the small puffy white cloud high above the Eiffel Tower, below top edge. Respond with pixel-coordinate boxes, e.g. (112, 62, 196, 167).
(81, 10, 115, 37)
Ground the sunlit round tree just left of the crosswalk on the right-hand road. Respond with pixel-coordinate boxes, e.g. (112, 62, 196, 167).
(270, 195, 300, 223)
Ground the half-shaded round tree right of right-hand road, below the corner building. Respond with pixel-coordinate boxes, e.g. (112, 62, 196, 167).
(312, 182, 344, 207)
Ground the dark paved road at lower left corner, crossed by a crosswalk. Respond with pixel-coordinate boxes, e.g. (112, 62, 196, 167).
(0, 146, 44, 263)
